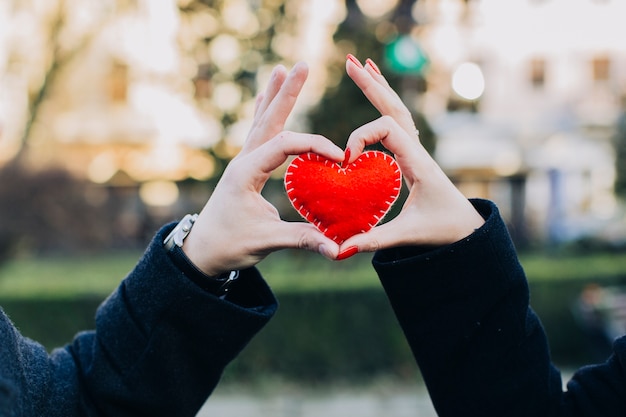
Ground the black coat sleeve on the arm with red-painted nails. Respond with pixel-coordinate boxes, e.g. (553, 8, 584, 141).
(373, 200, 626, 417)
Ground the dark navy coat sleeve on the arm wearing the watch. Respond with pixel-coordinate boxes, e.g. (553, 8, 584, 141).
(0, 225, 277, 417)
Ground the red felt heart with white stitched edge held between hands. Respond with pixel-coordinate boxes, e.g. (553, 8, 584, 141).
(285, 151, 402, 244)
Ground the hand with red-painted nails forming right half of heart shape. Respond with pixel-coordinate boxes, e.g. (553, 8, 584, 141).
(340, 55, 484, 254)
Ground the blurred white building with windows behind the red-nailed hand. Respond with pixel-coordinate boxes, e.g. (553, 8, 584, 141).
(411, 0, 626, 241)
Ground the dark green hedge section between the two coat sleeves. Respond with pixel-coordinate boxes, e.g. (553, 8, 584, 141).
(222, 289, 417, 381)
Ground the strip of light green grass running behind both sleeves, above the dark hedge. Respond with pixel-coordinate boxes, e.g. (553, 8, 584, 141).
(0, 247, 626, 298)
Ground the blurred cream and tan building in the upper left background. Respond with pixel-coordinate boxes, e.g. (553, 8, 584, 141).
(0, 0, 222, 214)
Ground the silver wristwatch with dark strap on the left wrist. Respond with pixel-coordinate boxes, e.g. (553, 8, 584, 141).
(163, 214, 239, 299)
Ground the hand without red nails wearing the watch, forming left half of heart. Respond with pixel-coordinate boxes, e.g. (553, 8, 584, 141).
(183, 63, 344, 275)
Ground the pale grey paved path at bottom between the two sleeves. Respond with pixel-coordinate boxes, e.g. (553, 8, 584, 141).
(197, 386, 437, 417)
